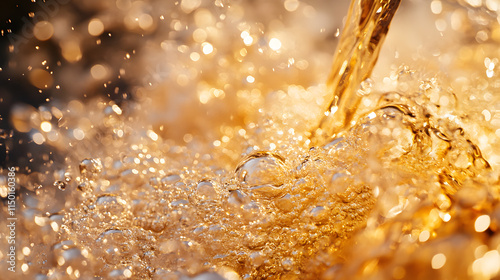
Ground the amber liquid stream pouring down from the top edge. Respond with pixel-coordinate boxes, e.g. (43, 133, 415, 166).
(311, 0, 401, 145)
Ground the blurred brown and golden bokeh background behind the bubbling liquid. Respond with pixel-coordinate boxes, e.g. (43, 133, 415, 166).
(0, 0, 499, 171)
